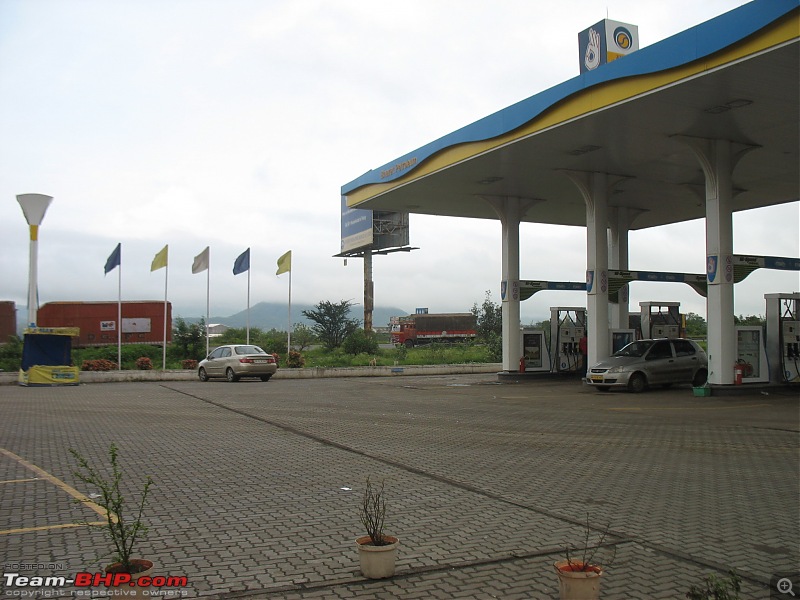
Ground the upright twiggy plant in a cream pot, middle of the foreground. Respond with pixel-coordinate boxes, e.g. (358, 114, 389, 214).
(356, 477, 399, 579)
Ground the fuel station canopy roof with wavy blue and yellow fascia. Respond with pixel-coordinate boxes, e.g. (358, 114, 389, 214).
(342, 0, 800, 229)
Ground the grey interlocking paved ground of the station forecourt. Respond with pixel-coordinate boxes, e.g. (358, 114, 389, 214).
(0, 375, 800, 599)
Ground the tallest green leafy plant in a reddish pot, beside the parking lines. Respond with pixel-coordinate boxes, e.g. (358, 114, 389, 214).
(69, 443, 153, 597)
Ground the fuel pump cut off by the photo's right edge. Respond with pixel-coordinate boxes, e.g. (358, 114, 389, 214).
(764, 293, 800, 383)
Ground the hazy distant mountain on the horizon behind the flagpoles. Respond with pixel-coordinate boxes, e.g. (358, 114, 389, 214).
(185, 302, 411, 331)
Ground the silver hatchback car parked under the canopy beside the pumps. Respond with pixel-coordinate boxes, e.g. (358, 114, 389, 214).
(586, 338, 708, 392)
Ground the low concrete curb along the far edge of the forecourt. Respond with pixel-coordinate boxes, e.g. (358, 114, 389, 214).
(0, 363, 502, 386)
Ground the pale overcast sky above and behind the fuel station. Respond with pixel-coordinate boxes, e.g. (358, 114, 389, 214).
(0, 0, 800, 325)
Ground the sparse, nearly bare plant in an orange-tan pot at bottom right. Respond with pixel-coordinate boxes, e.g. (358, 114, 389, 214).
(553, 515, 616, 600)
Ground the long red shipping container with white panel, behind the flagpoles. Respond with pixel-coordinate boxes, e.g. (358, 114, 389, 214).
(36, 300, 172, 348)
